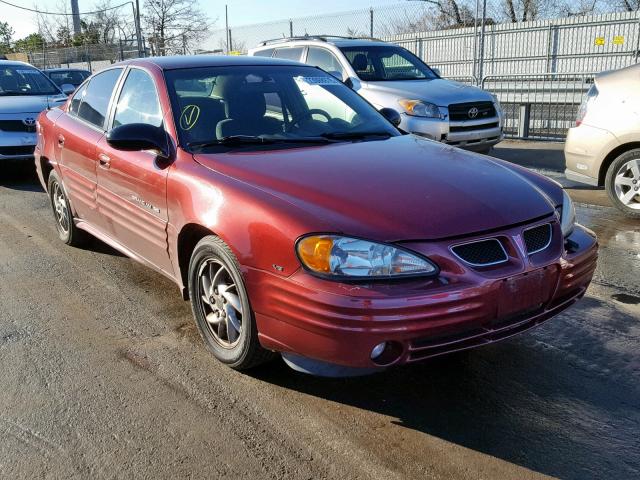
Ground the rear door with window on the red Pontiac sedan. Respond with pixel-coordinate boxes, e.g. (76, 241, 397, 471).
(55, 68, 122, 226)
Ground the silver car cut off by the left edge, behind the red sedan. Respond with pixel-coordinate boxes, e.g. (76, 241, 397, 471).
(0, 60, 73, 166)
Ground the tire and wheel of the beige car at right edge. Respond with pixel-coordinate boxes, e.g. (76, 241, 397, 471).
(605, 149, 640, 218)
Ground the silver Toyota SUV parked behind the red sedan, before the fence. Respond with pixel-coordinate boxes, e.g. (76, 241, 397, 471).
(249, 36, 503, 153)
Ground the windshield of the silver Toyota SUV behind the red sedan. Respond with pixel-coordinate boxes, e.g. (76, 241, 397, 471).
(340, 45, 438, 82)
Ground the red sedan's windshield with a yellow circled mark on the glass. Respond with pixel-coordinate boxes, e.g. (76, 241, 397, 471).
(165, 65, 399, 151)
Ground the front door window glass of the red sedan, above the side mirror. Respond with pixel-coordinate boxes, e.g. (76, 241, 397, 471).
(113, 68, 162, 127)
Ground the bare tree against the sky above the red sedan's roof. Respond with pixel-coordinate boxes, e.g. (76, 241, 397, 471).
(143, 0, 213, 55)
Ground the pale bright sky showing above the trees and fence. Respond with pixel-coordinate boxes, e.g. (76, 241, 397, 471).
(5, 0, 400, 38)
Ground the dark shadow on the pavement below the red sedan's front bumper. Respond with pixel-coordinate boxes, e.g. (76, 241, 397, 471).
(252, 298, 640, 479)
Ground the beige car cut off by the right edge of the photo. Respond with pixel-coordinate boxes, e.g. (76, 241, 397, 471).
(564, 65, 640, 218)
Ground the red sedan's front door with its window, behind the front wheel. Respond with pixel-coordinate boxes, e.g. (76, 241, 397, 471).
(97, 67, 173, 275)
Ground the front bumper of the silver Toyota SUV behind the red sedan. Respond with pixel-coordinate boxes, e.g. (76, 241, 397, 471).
(400, 114, 504, 150)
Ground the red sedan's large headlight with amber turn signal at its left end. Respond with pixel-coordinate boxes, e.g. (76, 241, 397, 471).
(296, 235, 439, 279)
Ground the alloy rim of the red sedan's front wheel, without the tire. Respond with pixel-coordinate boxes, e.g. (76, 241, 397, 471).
(198, 259, 243, 348)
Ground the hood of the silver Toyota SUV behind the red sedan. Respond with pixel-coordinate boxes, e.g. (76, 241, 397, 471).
(362, 78, 493, 107)
